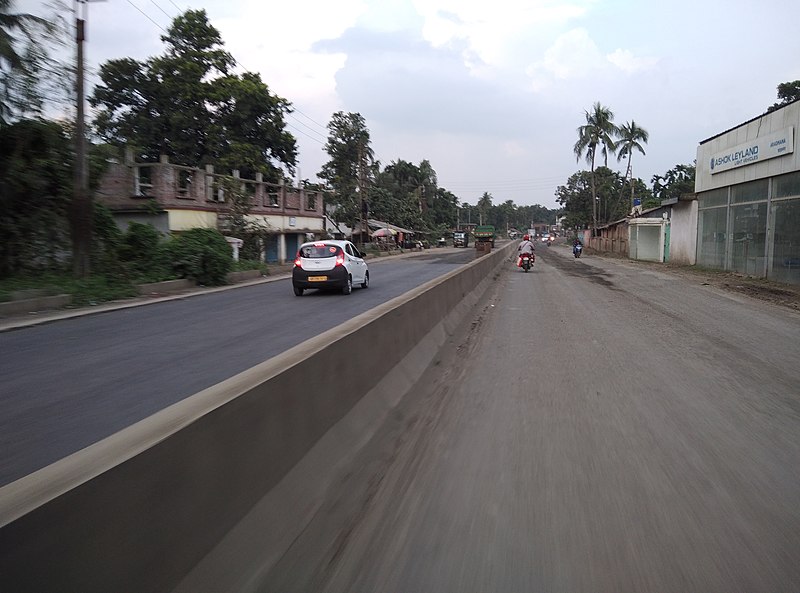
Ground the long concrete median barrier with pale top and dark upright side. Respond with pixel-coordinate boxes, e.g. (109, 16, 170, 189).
(0, 243, 514, 593)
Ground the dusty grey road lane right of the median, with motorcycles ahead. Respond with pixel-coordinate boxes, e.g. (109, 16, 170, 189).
(260, 247, 800, 593)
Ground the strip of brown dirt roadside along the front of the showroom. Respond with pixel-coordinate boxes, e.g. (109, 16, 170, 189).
(608, 254, 800, 311)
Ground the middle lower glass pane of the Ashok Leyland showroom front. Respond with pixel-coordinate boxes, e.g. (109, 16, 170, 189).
(731, 203, 767, 276)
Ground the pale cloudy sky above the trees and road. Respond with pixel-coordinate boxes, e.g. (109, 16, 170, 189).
(14, 0, 800, 208)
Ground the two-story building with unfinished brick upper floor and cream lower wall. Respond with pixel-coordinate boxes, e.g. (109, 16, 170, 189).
(95, 151, 325, 263)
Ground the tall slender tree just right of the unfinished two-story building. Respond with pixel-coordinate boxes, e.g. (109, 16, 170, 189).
(317, 111, 380, 227)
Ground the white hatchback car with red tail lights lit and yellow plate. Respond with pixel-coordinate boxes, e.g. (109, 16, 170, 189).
(292, 241, 369, 296)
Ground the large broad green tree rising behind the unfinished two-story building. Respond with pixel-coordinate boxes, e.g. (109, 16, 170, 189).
(90, 10, 297, 180)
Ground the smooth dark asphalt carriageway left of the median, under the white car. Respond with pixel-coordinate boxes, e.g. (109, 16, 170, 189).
(0, 249, 474, 485)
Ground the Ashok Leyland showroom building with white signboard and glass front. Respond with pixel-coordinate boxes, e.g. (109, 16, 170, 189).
(695, 101, 800, 284)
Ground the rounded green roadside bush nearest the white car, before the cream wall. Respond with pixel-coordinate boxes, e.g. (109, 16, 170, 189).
(166, 228, 233, 286)
